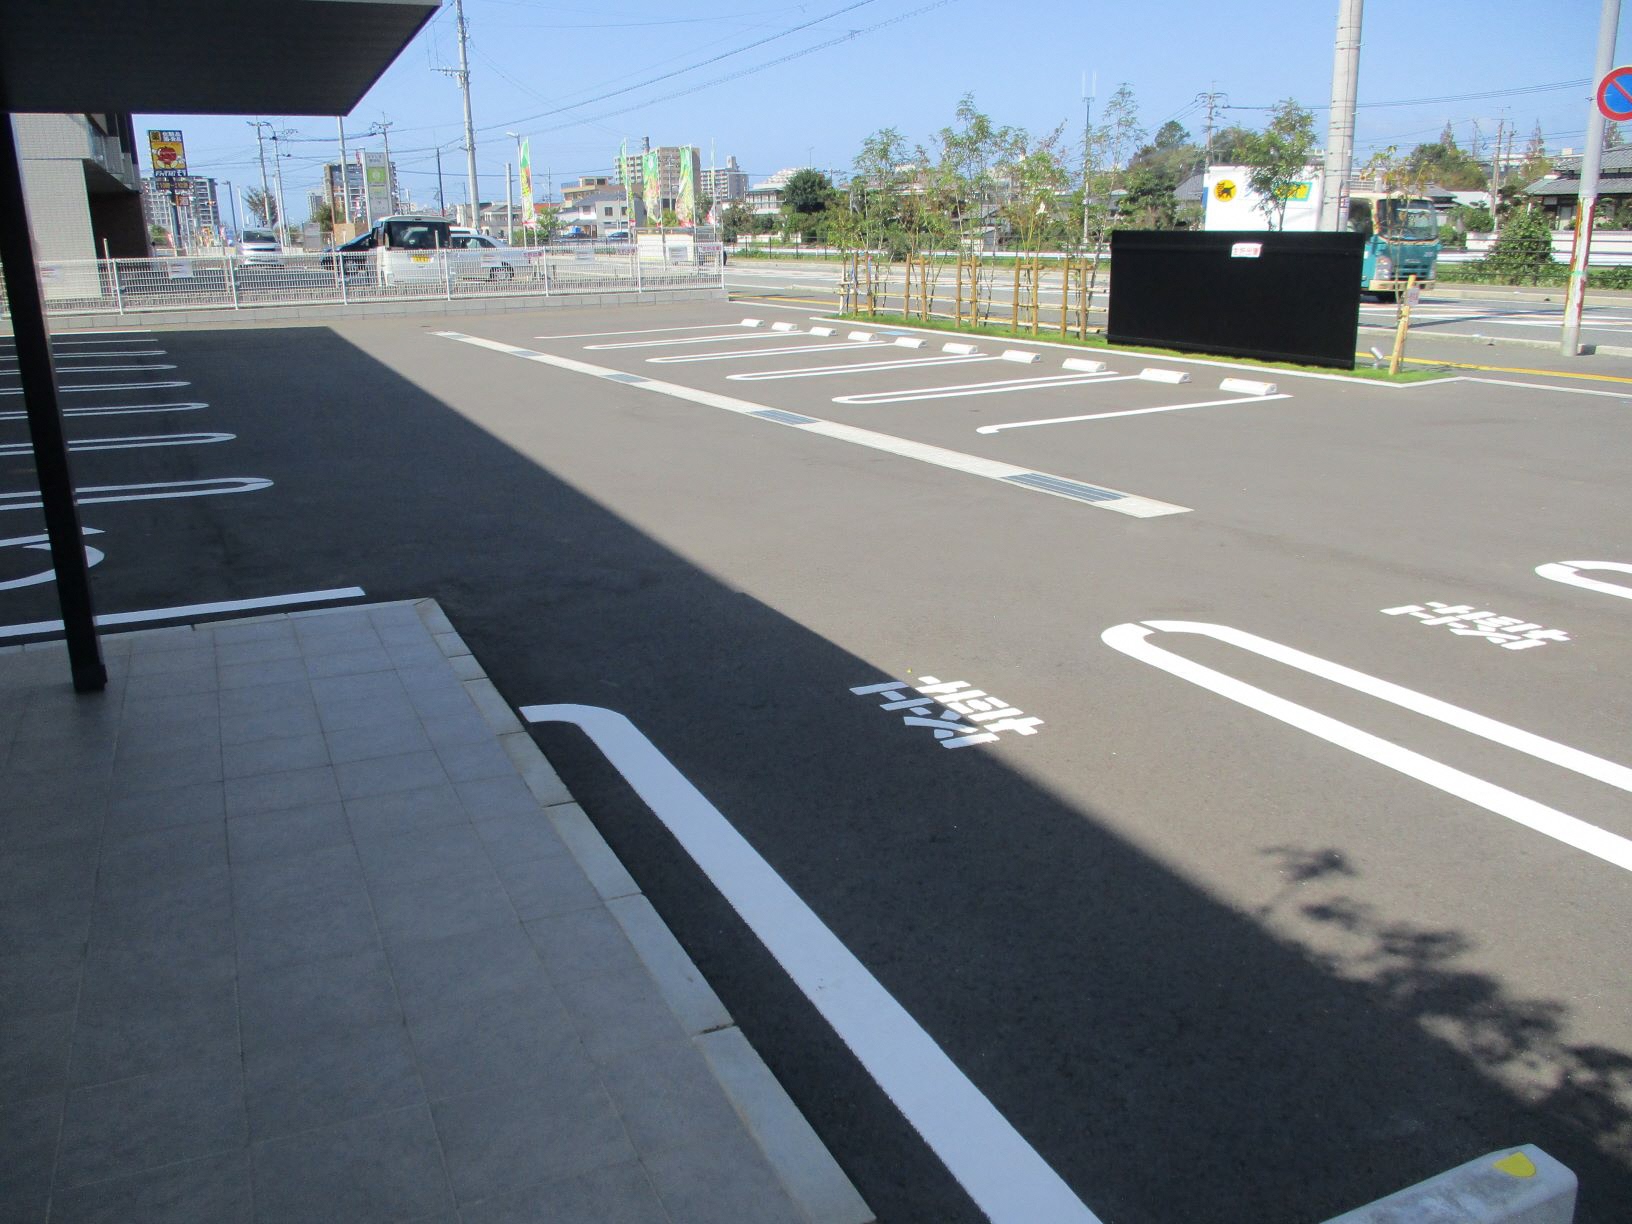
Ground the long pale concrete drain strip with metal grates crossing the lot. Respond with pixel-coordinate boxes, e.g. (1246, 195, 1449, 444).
(431, 331, 1188, 519)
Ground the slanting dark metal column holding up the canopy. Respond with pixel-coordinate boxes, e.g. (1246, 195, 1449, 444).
(0, 111, 108, 692)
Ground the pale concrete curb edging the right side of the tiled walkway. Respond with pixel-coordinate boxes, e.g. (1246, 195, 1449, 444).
(417, 599, 875, 1224)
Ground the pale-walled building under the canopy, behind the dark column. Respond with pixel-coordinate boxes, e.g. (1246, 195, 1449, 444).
(12, 114, 150, 261)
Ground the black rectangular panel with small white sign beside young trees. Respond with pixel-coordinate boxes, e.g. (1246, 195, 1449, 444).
(1105, 230, 1366, 369)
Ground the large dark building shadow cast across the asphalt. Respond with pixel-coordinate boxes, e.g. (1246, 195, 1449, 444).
(28, 330, 1632, 1224)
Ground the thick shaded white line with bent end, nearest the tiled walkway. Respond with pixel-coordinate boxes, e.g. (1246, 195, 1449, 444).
(521, 705, 1098, 1224)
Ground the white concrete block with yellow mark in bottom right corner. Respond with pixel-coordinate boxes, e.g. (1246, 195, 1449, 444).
(1327, 1144, 1577, 1224)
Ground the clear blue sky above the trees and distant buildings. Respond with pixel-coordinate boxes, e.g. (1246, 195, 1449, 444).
(137, 0, 1632, 219)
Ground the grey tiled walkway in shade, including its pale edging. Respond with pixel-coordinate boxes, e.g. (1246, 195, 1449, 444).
(0, 601, 871, 1224)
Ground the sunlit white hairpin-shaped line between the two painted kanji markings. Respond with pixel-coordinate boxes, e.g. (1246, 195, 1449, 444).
(1100, 620, 1632, 871)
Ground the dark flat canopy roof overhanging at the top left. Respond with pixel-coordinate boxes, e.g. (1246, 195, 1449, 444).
(0, 0, 439, 114)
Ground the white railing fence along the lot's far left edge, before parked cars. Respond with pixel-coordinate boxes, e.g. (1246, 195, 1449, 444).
(0, 243, 725, 315)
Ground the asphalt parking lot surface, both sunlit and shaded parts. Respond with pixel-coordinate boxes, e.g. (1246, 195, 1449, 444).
(0, 308, 1632, 1224)
